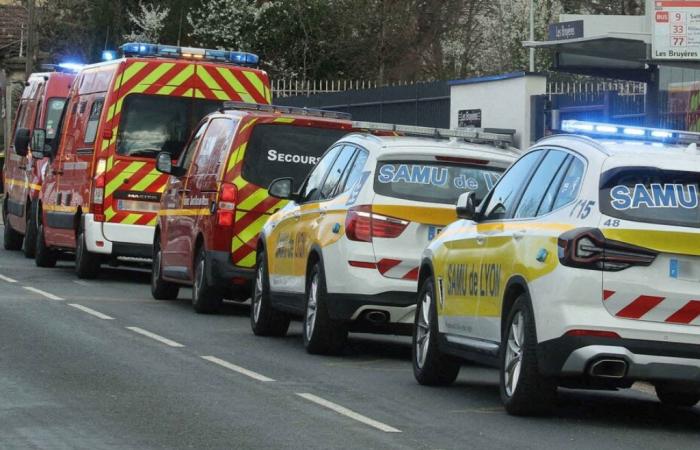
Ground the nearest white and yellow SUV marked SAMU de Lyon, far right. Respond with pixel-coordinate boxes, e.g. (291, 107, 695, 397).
(413, 121, 700, 414)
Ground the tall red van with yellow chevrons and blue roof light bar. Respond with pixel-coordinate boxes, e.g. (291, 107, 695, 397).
(35, 43, 270, 278)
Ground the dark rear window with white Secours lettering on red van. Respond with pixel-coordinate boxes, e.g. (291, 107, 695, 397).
(243, 124, 348, 187)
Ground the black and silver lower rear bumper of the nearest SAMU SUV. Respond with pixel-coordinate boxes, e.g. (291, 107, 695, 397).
(537, 336, 700, 386)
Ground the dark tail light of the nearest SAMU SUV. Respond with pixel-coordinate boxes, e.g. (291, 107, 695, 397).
(558, 228, 658, 272)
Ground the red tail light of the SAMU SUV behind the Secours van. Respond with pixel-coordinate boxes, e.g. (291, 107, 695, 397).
(345, 205, 409, 242)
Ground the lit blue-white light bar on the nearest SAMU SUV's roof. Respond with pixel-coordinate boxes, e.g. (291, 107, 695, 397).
(561, 120, 700, 144)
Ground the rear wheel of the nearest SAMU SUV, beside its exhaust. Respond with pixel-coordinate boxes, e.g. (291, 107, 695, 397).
(499, 294, 557, 416)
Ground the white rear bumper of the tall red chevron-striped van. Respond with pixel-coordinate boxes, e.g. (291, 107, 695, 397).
(83, 214, 155, 258)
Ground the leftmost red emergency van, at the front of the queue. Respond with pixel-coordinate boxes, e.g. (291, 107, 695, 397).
(3, 72, 75, 253)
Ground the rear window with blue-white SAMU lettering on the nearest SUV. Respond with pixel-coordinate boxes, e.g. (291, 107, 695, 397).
(600, 167, 700, 228)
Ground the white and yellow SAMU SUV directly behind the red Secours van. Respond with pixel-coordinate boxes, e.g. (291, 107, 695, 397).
(251, 122, 517, 353)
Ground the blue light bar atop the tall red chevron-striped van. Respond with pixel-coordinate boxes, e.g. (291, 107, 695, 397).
(120, 42, 260, 66)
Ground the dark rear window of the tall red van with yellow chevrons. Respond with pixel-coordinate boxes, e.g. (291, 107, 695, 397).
(117, 94, 222, 159)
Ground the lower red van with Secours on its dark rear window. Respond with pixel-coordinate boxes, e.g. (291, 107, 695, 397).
(151, 104, 352, 312)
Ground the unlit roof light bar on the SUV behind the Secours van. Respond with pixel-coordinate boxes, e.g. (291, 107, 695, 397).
(352, 121, 515, 147)
